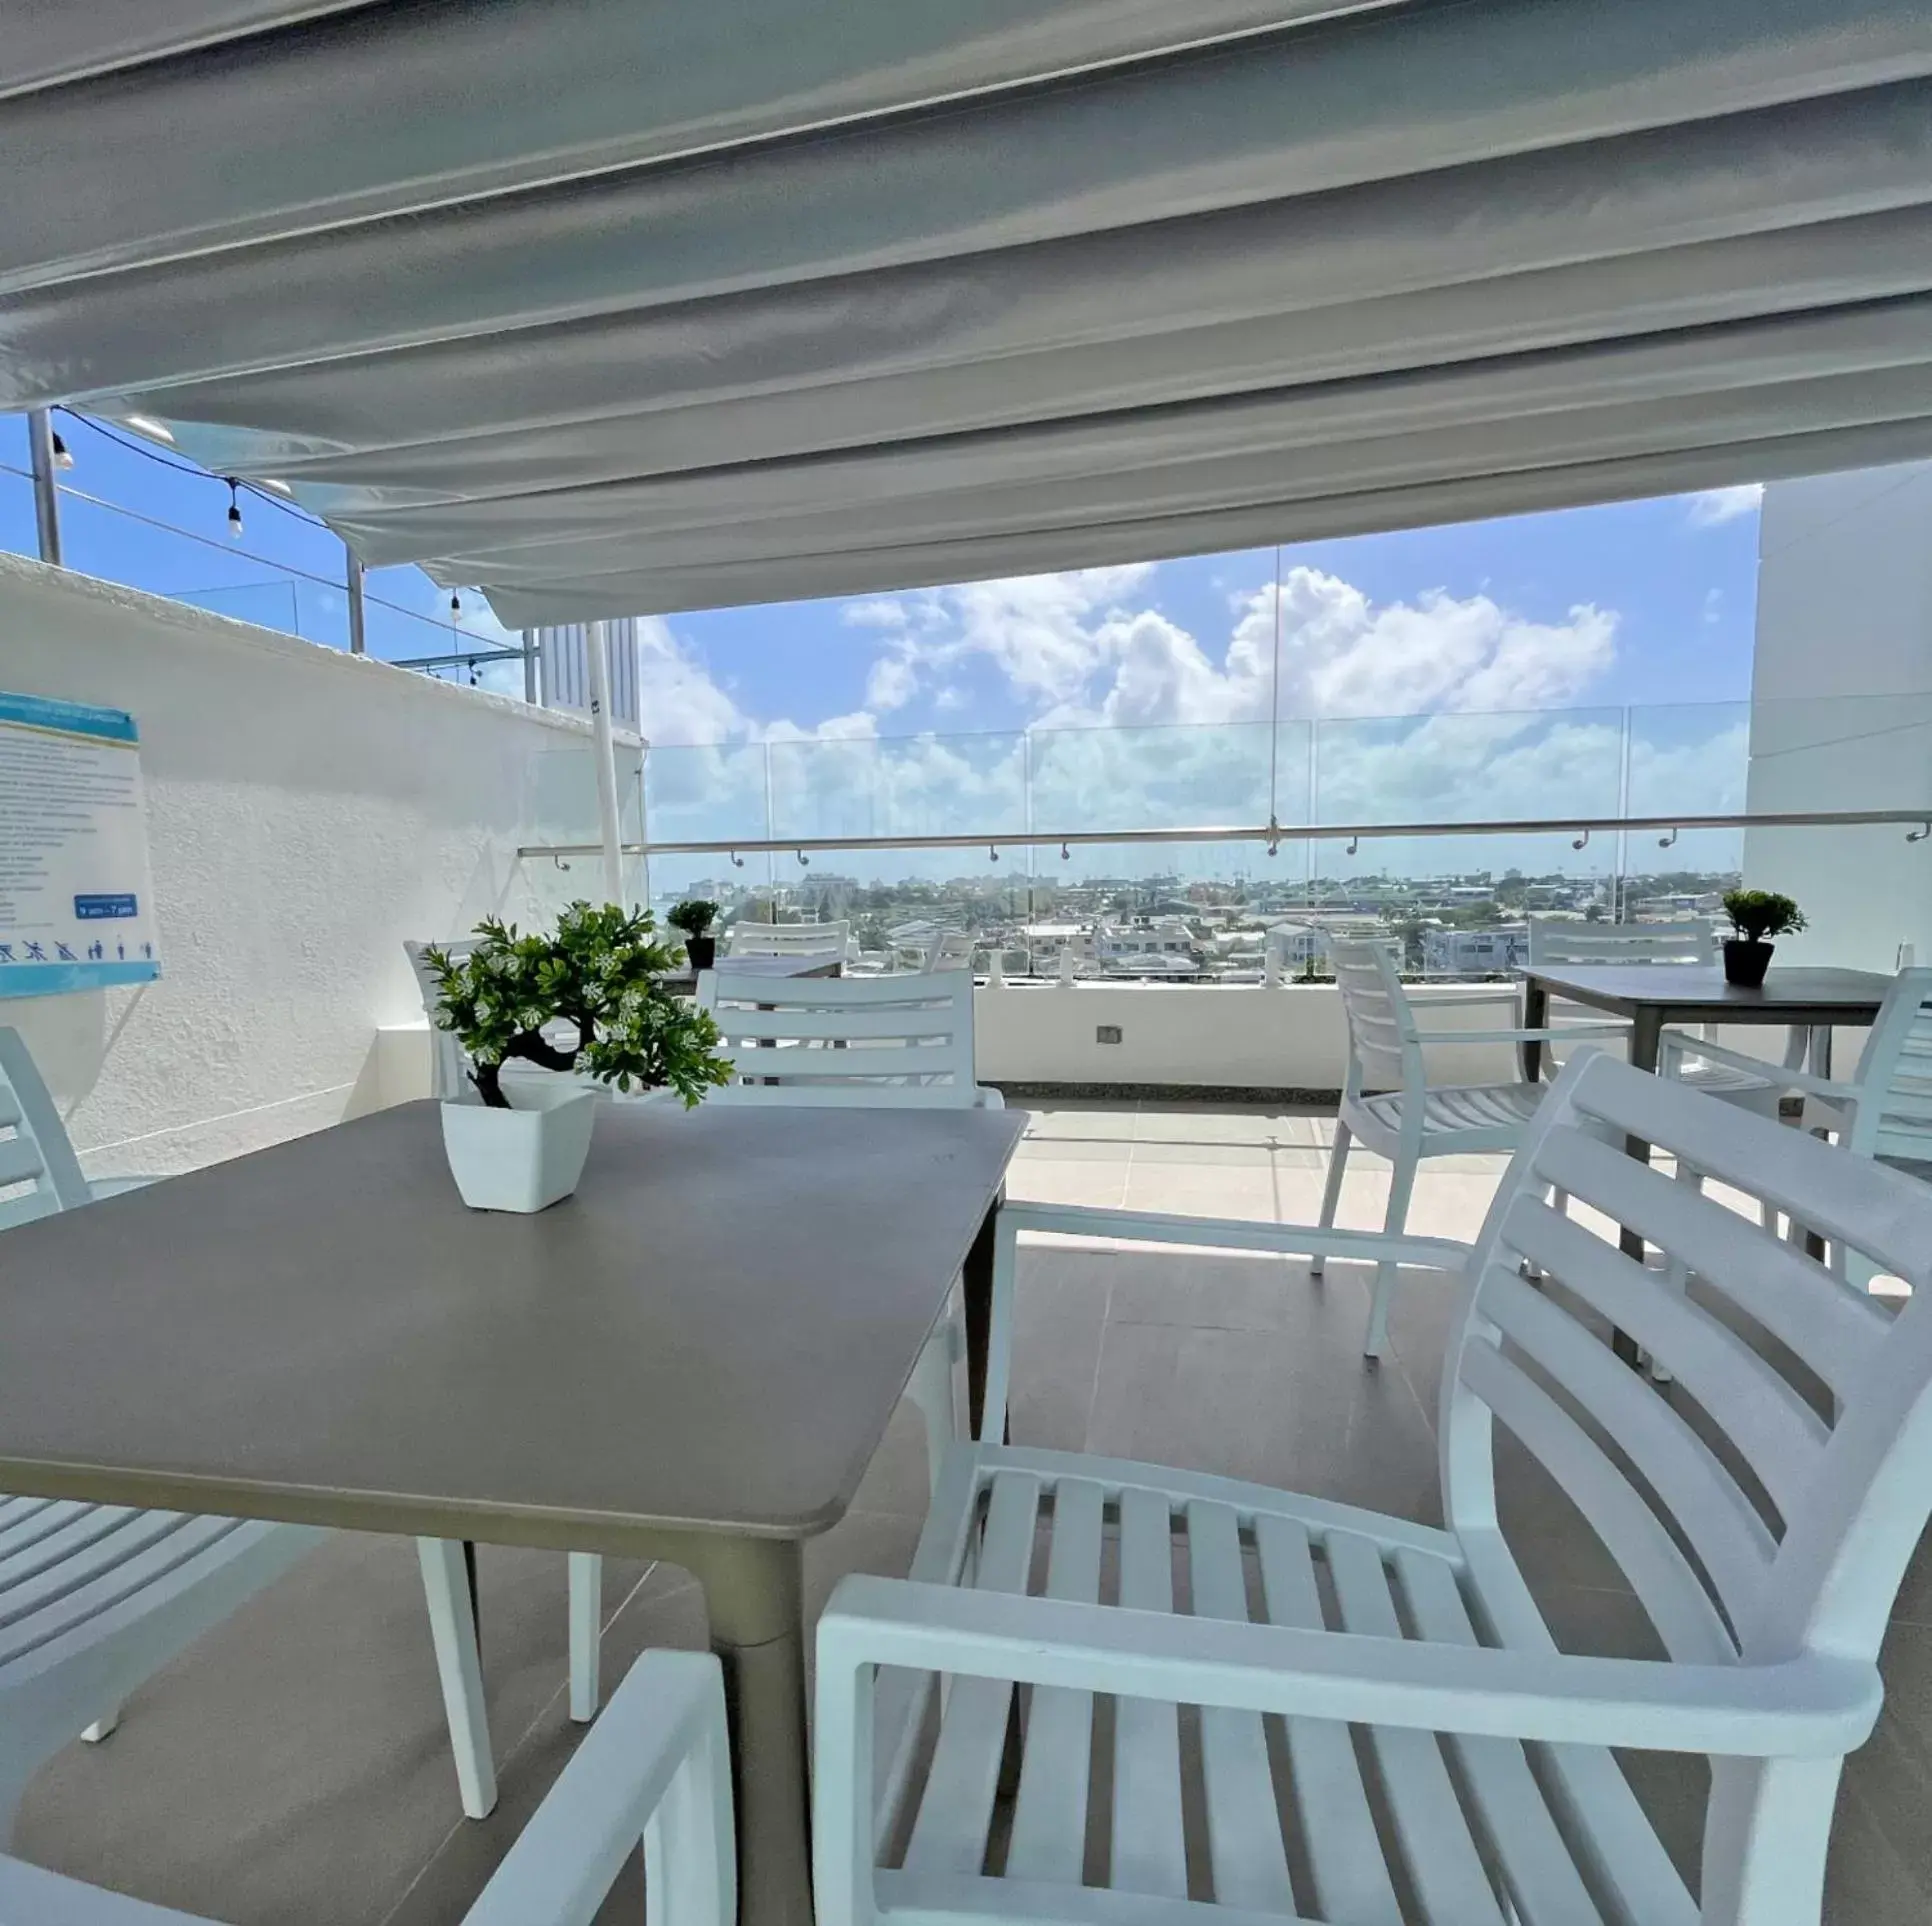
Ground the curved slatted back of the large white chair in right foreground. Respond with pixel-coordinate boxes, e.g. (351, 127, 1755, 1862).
(1441, 1053, 1932, 1922)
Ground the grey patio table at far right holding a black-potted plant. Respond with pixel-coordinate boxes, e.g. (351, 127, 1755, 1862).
(1519, 964, 1891, 1358)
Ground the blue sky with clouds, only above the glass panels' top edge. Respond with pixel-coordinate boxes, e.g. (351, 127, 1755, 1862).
(0, 401, 1758, 742)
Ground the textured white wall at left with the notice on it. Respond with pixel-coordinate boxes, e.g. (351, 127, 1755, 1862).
(0, 554, 622, 1175)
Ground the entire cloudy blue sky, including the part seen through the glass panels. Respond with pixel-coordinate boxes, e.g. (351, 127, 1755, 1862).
(0, 417, 1758, 888)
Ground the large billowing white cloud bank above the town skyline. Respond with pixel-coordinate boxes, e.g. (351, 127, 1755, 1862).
(625, 566, 1653, 877)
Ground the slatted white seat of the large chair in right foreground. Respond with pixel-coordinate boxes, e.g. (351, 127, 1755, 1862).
(877, 1447, 1696, 1926)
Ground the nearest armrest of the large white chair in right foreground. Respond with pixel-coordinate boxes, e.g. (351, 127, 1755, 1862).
(817, 1576, 1884, 1758)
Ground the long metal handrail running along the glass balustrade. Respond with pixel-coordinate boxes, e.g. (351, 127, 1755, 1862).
(516, 809, 1932, 856)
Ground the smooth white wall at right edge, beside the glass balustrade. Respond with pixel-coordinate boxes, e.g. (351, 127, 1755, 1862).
(1745, 462, 1932, 970)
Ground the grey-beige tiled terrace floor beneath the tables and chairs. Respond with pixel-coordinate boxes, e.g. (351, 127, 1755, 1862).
(15, 1105, 1932, 1926)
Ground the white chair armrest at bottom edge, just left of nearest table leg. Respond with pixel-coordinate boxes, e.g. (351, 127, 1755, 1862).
(464, 1652, 738, 1926)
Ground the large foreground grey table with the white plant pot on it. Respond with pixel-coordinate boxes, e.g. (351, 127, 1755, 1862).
(0, 1103, 1026, 1926)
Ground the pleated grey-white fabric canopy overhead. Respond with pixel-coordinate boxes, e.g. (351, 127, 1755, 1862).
(0, 0, 1932, 626)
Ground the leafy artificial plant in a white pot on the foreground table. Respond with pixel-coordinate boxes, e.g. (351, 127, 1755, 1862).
(423, 902, 730, 1211)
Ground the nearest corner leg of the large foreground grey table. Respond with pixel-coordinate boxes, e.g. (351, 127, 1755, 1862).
(678, 1536, 811, 1926)
